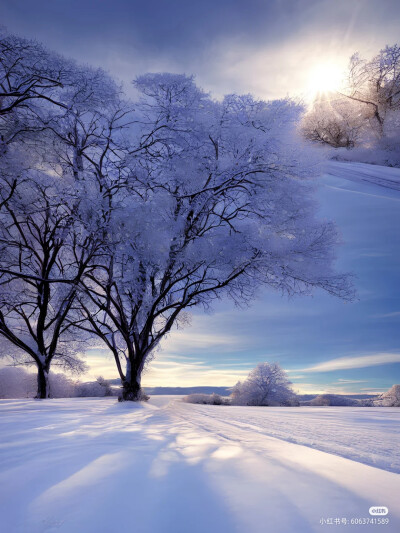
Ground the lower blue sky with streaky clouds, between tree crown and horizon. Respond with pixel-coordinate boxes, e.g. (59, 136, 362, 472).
(85, 172, 400, 394)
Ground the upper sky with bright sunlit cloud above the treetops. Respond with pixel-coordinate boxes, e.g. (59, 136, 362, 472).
(0, 0, 400, 102)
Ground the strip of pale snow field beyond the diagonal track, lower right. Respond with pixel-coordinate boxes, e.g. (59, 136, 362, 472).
(180, 405, 400, 473)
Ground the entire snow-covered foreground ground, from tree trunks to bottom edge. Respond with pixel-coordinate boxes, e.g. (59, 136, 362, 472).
(0, 397, 400, 533)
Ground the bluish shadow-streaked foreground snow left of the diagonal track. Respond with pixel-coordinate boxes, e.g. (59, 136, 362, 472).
(0, 402, 400, 533)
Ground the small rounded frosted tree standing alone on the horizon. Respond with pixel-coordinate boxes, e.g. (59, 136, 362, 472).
(231, 363, 298, 406)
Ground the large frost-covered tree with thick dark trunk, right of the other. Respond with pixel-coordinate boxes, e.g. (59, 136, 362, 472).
(75, 74, 351, 400)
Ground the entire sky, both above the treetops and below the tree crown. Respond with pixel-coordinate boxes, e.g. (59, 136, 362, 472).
(0, 0, 400, 392)
